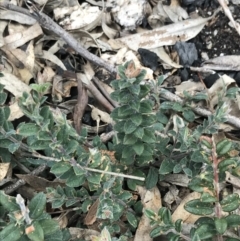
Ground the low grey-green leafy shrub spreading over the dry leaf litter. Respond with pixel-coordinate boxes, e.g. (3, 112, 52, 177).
(0, 62, 240, 241)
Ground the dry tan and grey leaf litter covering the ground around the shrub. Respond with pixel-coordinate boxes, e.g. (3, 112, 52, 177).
(0, 0, 240, 241)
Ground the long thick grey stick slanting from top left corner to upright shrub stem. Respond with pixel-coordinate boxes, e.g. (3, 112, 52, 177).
(0, 2, 117, 74)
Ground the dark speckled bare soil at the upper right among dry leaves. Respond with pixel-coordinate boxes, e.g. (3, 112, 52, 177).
(162, 0, 240, 88)
